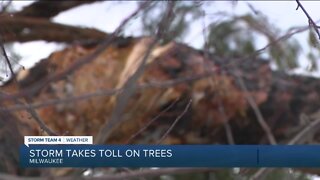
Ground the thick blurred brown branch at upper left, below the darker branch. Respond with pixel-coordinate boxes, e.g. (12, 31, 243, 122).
(0, 16, 107, 43)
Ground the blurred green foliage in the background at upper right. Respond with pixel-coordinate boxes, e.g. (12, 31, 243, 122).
(139, 1, 320, 71)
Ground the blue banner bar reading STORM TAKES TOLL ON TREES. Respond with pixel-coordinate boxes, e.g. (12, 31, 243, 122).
(20, 145, 320, 167)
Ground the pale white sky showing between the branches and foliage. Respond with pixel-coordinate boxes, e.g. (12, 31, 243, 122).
(6, 0, 320, 77)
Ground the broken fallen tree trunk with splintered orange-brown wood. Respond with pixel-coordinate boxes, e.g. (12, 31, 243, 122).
(0, 0, 320, 179)
